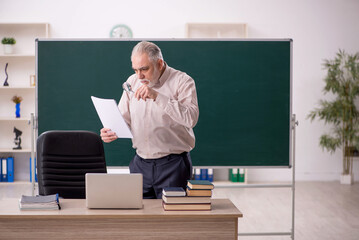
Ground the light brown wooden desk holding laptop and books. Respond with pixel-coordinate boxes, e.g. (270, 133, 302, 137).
(0, 199, 242, 240)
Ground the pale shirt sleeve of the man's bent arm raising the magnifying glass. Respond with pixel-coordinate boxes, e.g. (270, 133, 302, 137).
(155, 78, 199, 128)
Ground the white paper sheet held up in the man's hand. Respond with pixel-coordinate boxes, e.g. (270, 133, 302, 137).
(91, 96, 133, 138)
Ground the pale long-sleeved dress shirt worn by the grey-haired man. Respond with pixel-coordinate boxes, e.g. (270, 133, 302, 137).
(118, 65, 199, 159)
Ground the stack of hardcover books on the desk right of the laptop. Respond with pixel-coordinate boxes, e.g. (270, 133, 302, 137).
(162, 180, 213, 211)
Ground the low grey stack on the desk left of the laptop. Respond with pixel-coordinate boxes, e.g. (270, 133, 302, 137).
(19, 194, 61, 210)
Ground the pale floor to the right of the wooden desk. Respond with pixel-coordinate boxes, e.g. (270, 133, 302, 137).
(213, 182, 359, 240)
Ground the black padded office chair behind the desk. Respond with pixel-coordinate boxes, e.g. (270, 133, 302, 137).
(37, 131, 107, 198)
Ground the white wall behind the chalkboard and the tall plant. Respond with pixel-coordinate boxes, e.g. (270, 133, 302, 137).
(0, 0, 359, 181)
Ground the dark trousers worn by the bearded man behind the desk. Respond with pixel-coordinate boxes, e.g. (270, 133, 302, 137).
(129, 152, 192, 198)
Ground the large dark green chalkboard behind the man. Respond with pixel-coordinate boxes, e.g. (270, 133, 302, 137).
(36, 39, 292, 167)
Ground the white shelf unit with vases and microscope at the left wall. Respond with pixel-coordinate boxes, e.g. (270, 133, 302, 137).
(0, 22, 49, 181)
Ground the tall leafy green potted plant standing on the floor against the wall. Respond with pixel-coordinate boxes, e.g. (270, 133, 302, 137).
(308, 50, 359, 184)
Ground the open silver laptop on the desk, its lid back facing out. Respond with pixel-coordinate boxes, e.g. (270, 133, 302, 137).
(86, 173, 143, 208)
